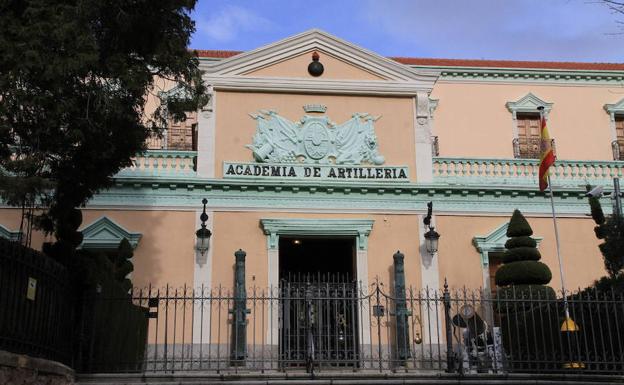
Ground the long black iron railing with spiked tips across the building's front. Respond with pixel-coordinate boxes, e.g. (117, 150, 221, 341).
(86, 282, 624, 374)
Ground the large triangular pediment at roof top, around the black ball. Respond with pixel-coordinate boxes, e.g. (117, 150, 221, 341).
(202, 29, 437, 85)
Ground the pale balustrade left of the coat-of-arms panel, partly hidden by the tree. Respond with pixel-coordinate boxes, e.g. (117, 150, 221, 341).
(117, 150, 197, 177)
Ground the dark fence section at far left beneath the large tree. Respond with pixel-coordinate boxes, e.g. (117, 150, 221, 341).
(0, 238, 74, 365)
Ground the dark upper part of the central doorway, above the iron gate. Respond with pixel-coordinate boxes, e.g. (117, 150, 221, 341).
(279, 237, 356, 282)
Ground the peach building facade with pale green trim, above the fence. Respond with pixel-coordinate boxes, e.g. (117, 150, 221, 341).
(0, 30, 624, 296)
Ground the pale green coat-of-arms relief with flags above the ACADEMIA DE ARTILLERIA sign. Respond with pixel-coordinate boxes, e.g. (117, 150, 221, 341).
(245, 110, 385, 165)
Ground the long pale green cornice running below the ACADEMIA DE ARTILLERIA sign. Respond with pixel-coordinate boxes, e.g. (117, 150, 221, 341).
(78, 174, 608, 216)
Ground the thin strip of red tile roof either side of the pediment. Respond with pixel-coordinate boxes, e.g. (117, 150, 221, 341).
(196, 49, 624, 71)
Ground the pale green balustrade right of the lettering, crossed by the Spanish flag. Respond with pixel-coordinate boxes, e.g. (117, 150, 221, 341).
(433, 158, 624, 187)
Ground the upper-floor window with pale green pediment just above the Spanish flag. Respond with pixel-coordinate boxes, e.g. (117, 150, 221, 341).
(506, 93, 556, 159)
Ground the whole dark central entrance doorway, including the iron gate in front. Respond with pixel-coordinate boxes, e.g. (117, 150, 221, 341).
(279, 237, 359, 371)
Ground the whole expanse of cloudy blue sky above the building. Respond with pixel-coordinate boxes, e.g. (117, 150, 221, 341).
(191, 0, 624, 62)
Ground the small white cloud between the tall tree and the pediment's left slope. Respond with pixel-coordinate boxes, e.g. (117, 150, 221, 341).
(196, 4, 272, 42)
